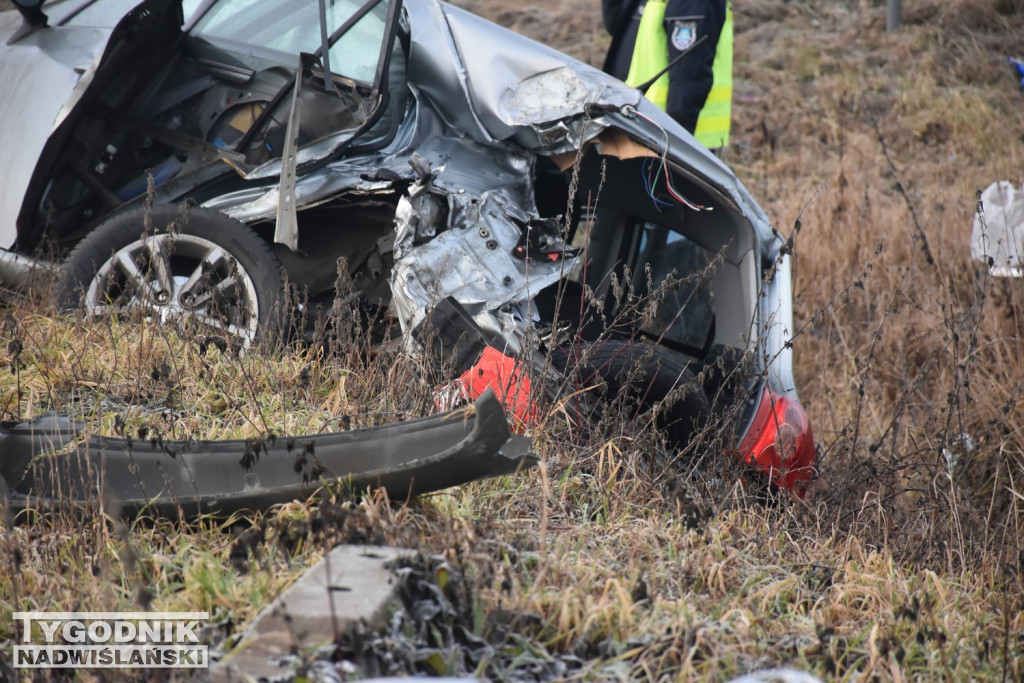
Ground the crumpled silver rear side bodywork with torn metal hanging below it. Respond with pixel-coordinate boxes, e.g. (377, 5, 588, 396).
(169, 2, 781, 352)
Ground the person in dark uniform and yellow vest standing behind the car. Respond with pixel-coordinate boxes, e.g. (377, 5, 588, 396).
(601, 0, 732, 148)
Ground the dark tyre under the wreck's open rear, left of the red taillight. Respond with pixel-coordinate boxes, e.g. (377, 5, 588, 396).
(551, 339, 711, 450)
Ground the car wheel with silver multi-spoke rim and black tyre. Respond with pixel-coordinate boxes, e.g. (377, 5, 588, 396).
(53, 205, 285, 346)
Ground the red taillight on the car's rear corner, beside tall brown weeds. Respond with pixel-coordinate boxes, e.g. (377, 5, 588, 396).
(739, 389, 817, 496)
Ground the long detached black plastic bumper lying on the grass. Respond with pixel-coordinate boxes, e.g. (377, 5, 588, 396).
(0, 391, 537, 515)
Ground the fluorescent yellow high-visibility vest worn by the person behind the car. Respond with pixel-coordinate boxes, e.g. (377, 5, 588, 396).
(626, 0, 732, 148)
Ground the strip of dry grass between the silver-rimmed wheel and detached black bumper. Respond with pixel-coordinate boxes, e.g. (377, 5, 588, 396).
(0, 309, 434, 439)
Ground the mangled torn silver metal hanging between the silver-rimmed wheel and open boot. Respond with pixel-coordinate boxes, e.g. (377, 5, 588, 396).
(390, 145, 575, 352)
